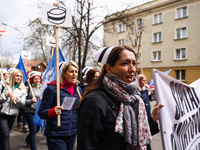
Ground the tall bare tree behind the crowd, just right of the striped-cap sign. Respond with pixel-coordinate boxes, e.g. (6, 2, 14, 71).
(60, 0, 133, 79)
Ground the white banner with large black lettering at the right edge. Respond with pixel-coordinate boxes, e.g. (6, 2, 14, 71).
(152, 69, 200, 150)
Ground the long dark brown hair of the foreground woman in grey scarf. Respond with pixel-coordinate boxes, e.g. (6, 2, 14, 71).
(83, 45, 136, 97)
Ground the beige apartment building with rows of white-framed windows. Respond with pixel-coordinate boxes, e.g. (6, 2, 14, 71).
(104, 0, 200, 84)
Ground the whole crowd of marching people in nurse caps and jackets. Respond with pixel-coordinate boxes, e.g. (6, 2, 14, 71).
(0, 46, 164, 150)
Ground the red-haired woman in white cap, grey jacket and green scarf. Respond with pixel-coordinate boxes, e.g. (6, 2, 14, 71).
(25, 71, 42, 150)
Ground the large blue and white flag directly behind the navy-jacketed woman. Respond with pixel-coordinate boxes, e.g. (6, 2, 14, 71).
(33, 48, 65, 129)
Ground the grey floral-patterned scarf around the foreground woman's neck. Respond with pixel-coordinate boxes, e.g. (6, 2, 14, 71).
(103, 73, 151, 150)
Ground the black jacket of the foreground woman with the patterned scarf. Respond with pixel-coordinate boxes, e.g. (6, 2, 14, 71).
(77, 88, 126, 150)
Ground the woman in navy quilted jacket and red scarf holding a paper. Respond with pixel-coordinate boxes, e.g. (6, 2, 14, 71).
(38, 61, 81, 150)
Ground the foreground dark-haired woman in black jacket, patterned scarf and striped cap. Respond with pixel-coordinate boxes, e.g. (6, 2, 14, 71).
(77, 46, 163, 150)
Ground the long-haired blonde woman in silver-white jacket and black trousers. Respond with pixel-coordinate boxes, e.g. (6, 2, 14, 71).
(0, 69, 27, 150)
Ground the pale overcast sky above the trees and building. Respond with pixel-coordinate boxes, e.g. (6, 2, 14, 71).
(0, 0, 150, 64)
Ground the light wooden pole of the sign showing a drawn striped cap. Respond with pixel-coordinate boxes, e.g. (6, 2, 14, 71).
(55, 25, 61, 126)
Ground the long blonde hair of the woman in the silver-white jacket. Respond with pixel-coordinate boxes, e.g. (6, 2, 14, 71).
(9, 69, 26, 90)
